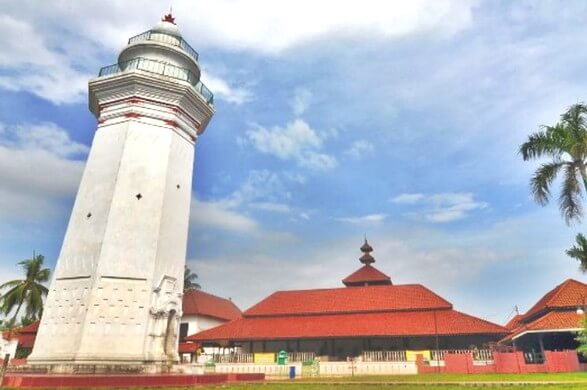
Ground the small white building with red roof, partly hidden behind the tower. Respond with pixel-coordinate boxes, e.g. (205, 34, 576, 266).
(179, 289, 242, 363)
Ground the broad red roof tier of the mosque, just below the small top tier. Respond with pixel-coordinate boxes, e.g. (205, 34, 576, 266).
(243, 284, 452, 317)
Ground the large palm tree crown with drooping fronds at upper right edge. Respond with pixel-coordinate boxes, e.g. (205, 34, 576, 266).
(520, 103, 587, 225)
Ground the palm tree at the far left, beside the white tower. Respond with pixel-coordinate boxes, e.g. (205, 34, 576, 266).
(0, 253, 51, 321)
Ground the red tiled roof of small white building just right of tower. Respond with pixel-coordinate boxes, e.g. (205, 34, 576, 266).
(183, 289, 241, 321)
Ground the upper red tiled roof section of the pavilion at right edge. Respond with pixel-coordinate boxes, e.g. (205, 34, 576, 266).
(521, 279, 587, 322)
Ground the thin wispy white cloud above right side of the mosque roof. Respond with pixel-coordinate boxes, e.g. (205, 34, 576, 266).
(390, 192, 489, 223)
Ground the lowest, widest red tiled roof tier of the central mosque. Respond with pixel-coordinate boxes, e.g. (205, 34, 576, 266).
(187, 309, 509, 341)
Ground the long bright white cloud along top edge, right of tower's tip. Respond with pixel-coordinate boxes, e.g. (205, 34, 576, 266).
(173, 0, 473, 52)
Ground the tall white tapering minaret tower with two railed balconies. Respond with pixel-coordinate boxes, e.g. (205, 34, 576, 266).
(28, 14, 214, 371)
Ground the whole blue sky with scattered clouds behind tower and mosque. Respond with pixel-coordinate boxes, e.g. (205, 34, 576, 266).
(0, 0, 587, 323)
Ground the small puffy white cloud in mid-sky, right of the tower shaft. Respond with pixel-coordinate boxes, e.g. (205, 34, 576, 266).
(245, 119, 337, 170)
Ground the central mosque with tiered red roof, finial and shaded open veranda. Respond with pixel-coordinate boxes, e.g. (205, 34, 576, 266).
(186, 240, 510, 360)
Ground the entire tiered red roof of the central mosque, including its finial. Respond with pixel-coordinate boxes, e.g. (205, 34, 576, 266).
(187, 240, 508, 342)
